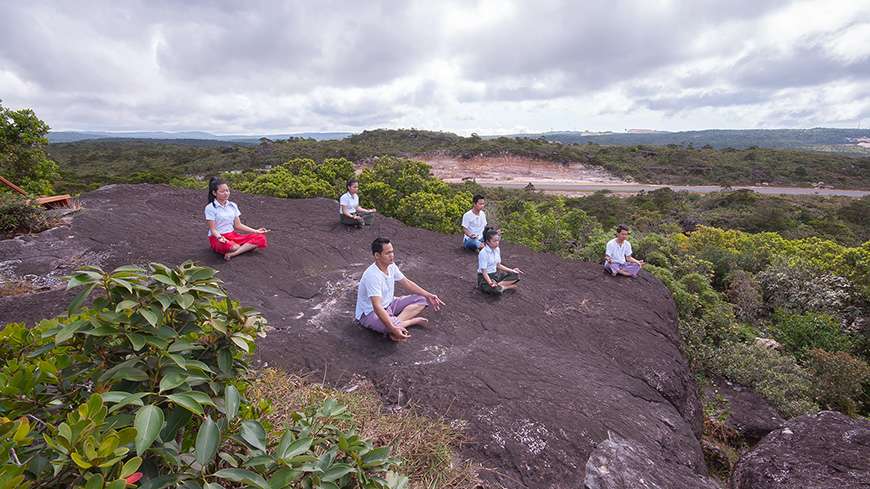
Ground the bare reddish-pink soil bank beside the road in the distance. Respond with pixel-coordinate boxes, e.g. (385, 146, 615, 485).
(415, 154, 630, 184)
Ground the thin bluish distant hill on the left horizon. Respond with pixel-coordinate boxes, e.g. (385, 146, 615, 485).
(48, 131, 352, 144)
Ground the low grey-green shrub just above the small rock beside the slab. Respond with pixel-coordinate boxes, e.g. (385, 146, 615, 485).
(711, 343, 818, 418)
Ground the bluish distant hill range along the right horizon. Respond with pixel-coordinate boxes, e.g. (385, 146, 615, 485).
(508, 127, 870, 149)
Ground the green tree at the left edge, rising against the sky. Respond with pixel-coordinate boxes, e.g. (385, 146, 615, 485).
(0, 104, 60, 194)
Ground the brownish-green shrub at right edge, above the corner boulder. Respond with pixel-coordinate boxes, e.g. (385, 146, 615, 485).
(806, 348, 870, 416)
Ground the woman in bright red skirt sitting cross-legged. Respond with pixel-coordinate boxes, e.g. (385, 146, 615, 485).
(205, 177, 269, 261)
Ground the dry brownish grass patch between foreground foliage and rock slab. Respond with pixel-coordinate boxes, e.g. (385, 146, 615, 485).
(247, 369, 480, 489)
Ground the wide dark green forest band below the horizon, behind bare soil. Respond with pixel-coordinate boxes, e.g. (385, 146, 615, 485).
(48, 129, 870, 191)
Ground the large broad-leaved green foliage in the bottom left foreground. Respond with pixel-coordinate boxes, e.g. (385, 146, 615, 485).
(0, 263, 407, 489)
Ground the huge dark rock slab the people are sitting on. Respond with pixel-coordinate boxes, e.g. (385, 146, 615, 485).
(0, 185, 713, 489)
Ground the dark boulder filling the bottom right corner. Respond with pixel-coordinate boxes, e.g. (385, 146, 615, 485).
(731, 411, 870, 489)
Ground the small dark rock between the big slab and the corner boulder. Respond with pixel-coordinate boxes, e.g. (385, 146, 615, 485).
(704, 380, 785, 445)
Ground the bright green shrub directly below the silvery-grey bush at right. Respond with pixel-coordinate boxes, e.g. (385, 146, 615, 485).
(772, 311, 855, 360)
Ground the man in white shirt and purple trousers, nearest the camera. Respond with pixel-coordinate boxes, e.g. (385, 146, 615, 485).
(354, 238, 444, 341)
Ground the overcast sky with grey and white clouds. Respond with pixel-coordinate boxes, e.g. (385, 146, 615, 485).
(0, 0, 870, 134)
